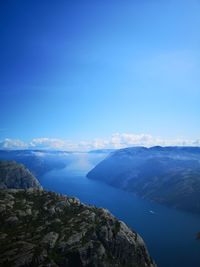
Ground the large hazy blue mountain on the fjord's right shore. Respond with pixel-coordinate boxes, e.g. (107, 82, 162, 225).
(87, 146, 200, 213)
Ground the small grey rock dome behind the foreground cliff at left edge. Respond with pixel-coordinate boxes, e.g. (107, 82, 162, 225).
(0, 161, 41, 189)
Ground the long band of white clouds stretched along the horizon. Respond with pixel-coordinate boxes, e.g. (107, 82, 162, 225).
(0, 133, 200, 151)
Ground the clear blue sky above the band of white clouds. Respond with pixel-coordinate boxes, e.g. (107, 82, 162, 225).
(0, 0, 200, 150)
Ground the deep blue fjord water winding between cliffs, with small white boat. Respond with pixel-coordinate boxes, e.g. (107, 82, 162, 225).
(40, 154, 200, 267)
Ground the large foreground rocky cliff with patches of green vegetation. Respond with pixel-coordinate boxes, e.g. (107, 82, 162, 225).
(0, 189, 155, 267)
